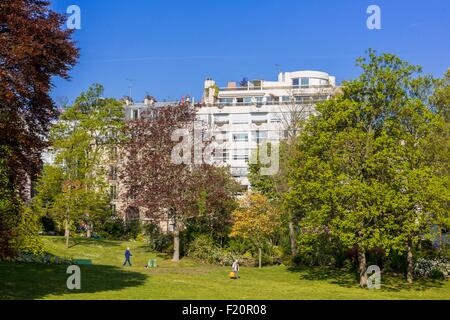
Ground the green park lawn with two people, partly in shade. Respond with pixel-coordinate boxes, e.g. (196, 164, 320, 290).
(0, 237, 450, 300)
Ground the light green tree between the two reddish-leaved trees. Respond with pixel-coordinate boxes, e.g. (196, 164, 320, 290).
(36, 85, 124, 245)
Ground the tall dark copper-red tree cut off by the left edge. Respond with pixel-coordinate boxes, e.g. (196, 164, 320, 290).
(0, 0, 78, 254)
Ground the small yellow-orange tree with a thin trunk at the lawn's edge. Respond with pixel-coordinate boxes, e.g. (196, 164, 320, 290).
(230, 193, 281, 268)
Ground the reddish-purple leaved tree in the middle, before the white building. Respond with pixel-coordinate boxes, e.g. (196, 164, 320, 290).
(120, 104, 235, 261)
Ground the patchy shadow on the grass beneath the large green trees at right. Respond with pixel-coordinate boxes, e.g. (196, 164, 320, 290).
(288, 267, 444, 292)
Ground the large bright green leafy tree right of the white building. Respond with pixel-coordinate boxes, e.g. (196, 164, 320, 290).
(289, 50, 448, 287)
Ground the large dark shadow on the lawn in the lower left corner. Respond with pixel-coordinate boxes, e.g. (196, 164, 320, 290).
(0, 262, 148, 300)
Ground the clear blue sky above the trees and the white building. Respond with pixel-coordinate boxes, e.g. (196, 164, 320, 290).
(52, 0, 450, 100)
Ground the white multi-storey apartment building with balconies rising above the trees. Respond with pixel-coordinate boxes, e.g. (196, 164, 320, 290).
(198, 71, 336, 189)
